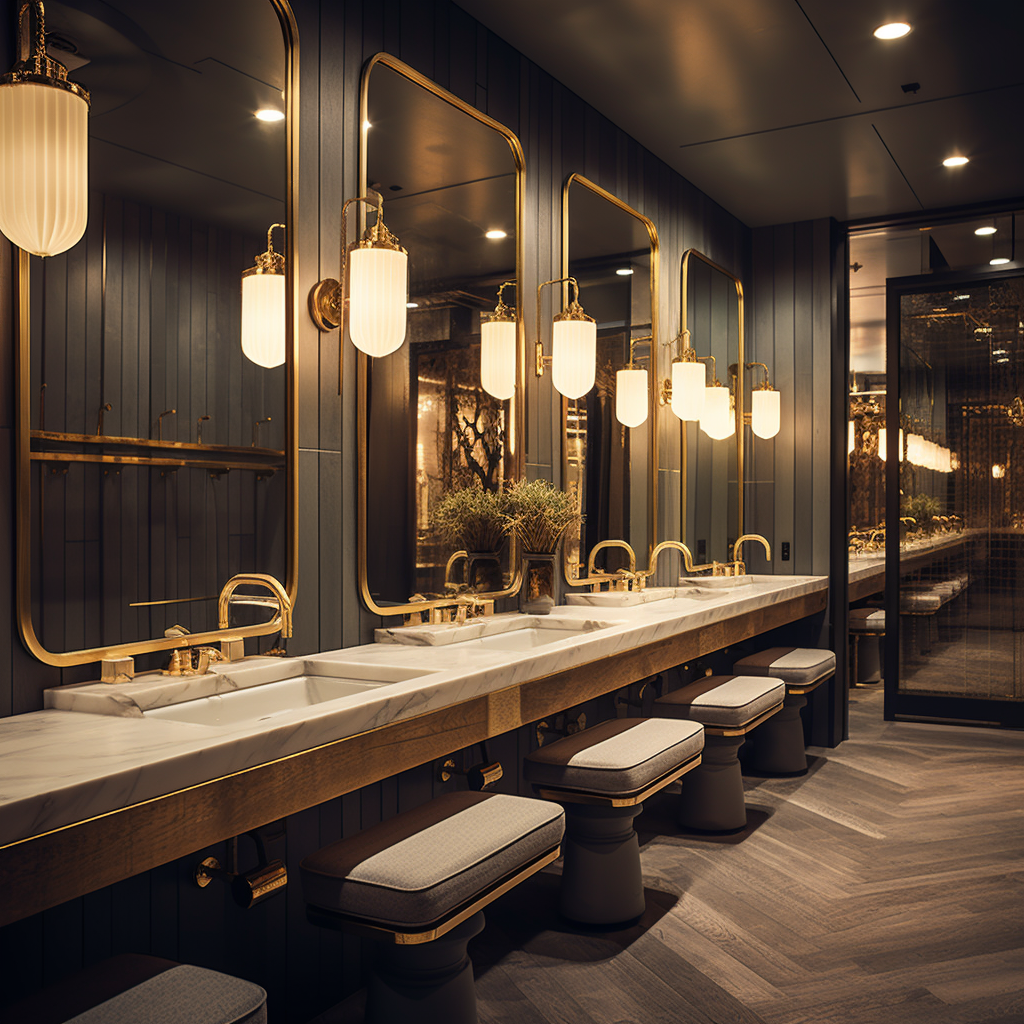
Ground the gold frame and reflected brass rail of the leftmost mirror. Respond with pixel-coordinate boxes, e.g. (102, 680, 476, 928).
(14, 0, 305, 668)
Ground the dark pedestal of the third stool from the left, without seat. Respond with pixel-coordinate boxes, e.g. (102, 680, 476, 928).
(559, 804, 644, 925)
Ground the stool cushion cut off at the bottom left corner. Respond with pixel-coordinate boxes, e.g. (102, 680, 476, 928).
(0, 954, 266, 1024)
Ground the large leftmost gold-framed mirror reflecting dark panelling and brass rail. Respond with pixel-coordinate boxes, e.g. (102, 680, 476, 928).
(15, 0, 298, 667)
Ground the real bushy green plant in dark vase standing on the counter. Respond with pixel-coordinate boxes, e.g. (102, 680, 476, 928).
(505, 480, 581, 615)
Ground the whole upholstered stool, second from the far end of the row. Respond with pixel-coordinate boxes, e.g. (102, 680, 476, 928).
(654, 676, 785, 831)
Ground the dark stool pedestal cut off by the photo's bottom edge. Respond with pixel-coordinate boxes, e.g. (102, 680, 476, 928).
(366, 910, 483, 1024)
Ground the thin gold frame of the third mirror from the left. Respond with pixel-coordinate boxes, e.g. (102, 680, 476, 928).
(561, 173, 662, 587)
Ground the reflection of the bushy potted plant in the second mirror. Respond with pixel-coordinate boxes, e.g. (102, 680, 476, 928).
(432, 482, 507, 593)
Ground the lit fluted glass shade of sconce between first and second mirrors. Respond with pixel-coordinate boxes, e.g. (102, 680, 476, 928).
(348, 245, 409, 356)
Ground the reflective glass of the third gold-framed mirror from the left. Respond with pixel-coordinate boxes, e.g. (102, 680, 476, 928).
(562, 174, 657, 577)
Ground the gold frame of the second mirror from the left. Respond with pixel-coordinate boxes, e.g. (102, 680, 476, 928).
(354, 53, 526, 616)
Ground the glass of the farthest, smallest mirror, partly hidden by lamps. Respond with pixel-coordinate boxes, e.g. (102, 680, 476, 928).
(681, 249, 753, 564)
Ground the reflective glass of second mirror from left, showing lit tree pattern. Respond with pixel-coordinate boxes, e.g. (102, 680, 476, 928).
(358, 54, 522, 614)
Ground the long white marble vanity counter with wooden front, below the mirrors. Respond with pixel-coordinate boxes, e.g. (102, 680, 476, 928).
(0, 575, 827, 924)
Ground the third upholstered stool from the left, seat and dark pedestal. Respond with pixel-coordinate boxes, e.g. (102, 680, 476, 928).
(523, 718, 703, 925)
